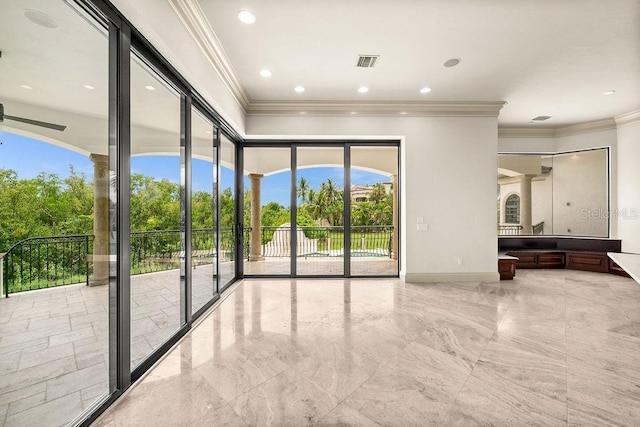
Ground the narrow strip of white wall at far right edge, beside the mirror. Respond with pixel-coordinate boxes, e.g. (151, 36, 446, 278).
(616, 121, 640, 253)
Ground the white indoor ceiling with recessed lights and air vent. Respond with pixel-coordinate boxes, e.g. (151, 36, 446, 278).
(199, 0, 640, 127)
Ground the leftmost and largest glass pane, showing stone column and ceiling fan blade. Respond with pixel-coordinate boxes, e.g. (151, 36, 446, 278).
(0, 0, 110, 426)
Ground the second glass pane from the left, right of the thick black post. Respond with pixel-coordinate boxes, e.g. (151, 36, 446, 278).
(130, 54, 184, 368)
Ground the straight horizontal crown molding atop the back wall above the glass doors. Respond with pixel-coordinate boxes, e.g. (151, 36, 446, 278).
(247, 101, 505, 117)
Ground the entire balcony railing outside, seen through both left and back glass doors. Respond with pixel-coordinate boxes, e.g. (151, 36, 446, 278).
(0, 226, 393, 296)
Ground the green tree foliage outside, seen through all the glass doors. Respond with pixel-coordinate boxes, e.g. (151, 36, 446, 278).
(0, 166, 393, 251)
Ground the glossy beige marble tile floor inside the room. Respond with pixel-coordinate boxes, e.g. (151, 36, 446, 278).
(95, 270, 640, 427)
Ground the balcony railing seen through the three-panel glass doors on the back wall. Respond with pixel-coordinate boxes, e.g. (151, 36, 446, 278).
(258, 226, 393, 257)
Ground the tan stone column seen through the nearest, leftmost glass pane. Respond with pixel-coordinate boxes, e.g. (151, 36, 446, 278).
(89, 154, 109, 286)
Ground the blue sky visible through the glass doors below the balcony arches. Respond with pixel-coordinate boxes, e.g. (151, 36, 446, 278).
(0, 132, 389, 207)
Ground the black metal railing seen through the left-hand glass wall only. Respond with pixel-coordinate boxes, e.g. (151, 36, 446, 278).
(0, 227, 251, 296)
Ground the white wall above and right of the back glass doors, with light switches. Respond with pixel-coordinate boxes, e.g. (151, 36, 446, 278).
(246, 116, 498, 281)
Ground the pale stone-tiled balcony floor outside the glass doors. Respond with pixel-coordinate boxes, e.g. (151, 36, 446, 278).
(0, 258, 395, 426)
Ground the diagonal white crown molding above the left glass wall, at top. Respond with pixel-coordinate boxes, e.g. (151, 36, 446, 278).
(168, 0, 250, 111)
